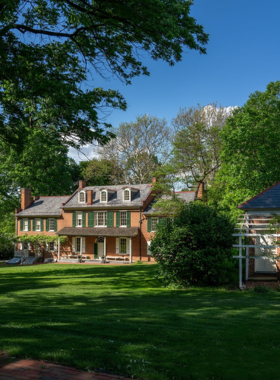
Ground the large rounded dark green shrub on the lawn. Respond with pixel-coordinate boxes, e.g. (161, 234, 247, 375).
(150, 202, 235, 286)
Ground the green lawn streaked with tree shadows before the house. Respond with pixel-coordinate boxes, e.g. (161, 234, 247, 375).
(0, 264, 280, 380)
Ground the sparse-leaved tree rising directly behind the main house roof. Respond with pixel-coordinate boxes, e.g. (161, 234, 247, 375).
(98, 115, 173, 184)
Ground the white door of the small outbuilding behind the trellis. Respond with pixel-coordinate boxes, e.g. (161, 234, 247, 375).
(255, 231, 276, 273)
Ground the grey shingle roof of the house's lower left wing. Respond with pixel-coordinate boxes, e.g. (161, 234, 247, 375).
(17, 195, 69, 216)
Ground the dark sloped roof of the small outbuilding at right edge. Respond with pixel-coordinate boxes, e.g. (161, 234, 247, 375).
(238, 182, 280, 210)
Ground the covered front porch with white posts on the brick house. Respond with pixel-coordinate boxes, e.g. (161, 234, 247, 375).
(57, 227, 139, 263)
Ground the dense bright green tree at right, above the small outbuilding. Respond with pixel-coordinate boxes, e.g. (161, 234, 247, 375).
(209, 81, 280, 214)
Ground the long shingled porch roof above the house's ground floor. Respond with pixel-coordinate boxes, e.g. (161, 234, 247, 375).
(56, 227, 138, 237)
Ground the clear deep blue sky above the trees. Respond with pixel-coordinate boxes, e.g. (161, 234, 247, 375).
(70, 0, 280, 160)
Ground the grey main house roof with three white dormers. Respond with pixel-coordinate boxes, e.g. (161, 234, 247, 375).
(64, 184, 151, 209)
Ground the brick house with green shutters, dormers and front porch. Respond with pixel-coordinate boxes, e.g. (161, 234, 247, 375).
(15, 179, 195, 262)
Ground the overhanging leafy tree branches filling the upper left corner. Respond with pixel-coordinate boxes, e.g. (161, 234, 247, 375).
(0, 0, 208, 148)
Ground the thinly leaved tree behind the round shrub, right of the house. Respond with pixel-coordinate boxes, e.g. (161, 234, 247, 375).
(171, 103, 231, 199)
